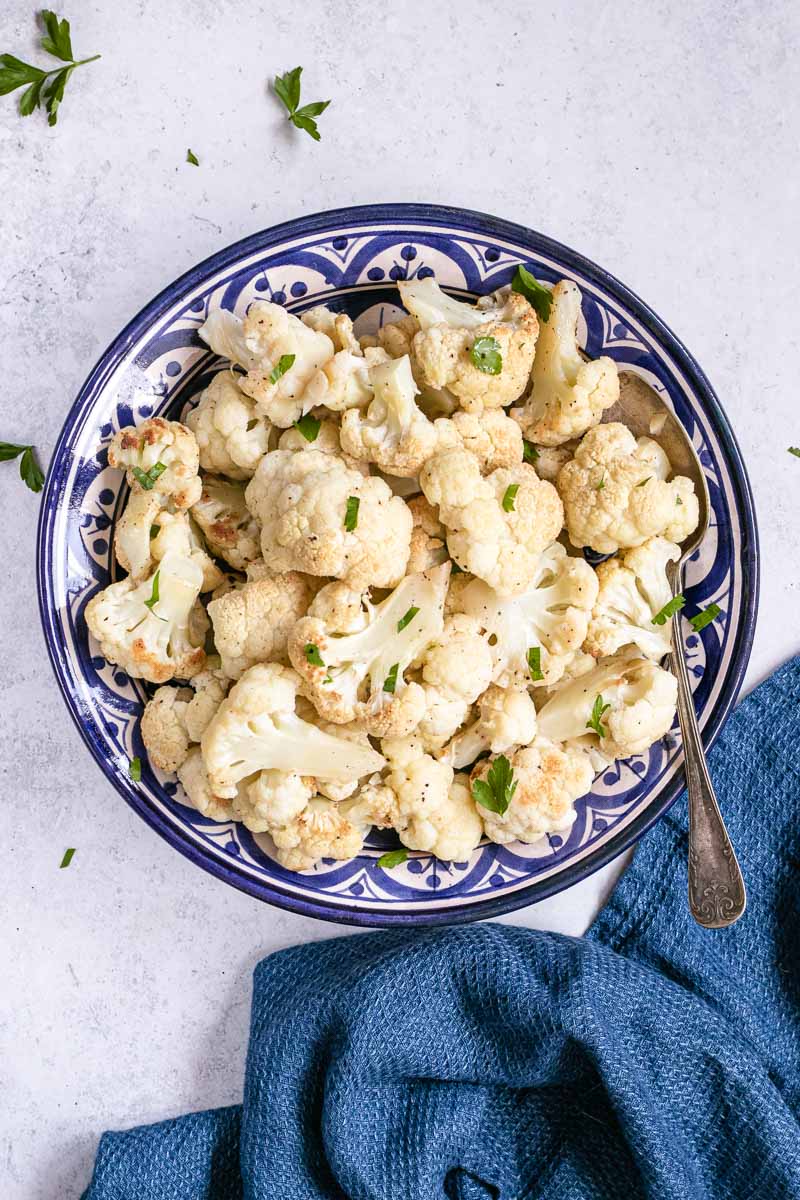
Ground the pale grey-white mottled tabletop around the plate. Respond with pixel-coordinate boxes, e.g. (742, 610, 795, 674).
(0, 0, 800, 1200)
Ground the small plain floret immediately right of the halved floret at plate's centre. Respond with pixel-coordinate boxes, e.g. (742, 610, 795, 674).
(419, 613, 494, 750)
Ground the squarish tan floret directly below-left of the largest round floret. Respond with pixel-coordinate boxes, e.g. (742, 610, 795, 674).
(209, 571, 311, 679)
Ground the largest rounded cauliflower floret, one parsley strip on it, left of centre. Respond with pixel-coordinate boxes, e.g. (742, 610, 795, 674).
(246, 450, 411, 589)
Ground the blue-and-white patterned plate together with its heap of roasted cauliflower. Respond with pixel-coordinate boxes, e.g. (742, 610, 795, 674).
(38, 205, 758, 925)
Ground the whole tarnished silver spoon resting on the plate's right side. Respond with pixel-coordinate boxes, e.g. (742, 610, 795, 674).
(604, 371, 747, 929)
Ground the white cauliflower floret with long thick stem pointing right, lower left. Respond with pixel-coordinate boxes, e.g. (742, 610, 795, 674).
(201, 662, 384, 797)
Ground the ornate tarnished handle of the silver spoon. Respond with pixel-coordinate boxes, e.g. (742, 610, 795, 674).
(672, 572, 747, 929)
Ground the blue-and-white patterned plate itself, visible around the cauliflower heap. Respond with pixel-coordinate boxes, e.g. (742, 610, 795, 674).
(37, 204, 758, 925)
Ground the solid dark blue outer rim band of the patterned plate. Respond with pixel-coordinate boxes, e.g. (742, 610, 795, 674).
(36, 203, 759, 928)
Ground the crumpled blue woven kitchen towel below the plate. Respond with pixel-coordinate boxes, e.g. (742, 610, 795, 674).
(79, 660, 800, 1200)
